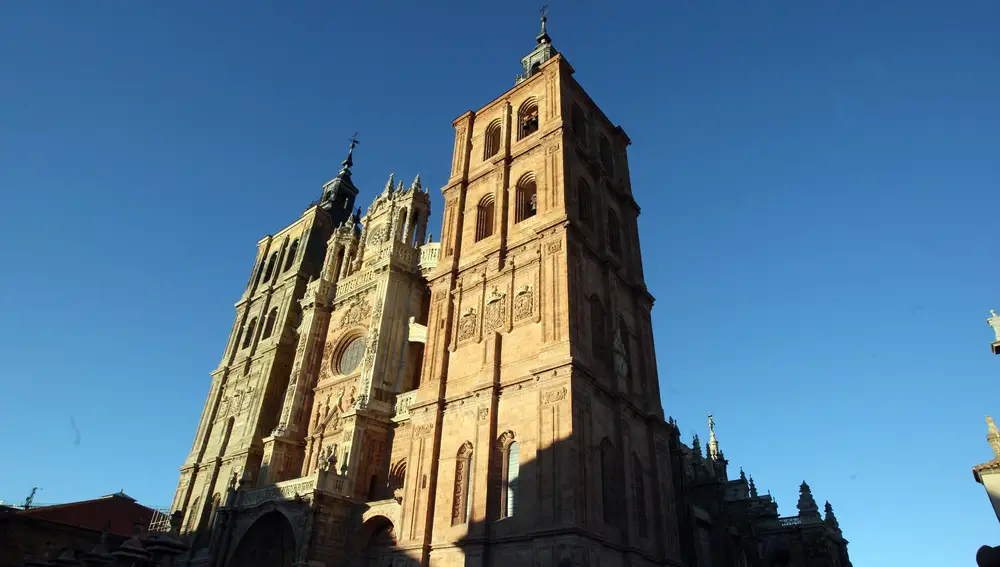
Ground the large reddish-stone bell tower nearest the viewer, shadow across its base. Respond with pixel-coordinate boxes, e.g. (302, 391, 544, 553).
(397, 12, 679, 565)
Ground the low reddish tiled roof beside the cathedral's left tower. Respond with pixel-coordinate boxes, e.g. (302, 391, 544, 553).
(17, 492, 154, 537)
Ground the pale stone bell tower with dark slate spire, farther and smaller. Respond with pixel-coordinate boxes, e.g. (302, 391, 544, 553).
(172, 139, 358, 554)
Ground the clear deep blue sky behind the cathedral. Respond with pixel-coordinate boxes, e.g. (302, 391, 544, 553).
(0, 0, 1000, 567)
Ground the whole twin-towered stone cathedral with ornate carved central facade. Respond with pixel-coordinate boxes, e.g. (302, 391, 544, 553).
(164, 16, 850, 567)
